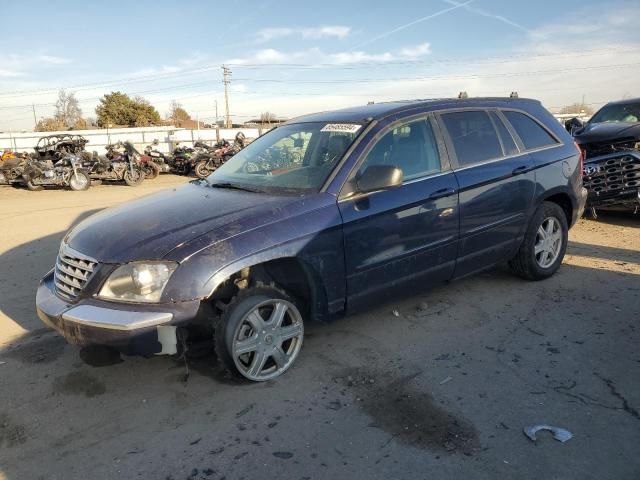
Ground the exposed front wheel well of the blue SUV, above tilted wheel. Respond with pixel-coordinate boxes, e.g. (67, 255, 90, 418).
(210, 257, 326, 318)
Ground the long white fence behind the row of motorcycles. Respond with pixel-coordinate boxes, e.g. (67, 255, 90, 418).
(0, 127, 262, 153)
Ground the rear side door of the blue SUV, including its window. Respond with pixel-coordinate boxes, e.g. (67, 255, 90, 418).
(438, 109, 535, 277)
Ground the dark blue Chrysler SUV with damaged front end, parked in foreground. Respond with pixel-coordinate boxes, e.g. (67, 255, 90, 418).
(36, 98, 586, 381)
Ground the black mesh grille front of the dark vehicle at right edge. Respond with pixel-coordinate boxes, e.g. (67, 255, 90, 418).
(583, 150, 640, 212)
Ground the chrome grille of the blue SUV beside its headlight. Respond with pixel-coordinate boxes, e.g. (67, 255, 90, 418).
(54, 244, 98, 300)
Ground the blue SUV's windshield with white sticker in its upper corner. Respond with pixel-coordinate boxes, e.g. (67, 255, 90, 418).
(207, 122, 362, 194)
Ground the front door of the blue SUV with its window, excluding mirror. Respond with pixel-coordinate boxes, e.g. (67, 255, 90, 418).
(338, 116, 458, 311)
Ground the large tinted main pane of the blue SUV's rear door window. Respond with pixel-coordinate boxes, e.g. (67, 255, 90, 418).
(441, 110, 503, 167)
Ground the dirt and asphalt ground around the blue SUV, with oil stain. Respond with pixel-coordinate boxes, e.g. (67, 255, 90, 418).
(0, 176, 640, 480)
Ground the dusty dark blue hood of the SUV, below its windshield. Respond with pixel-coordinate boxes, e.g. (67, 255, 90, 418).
(65, 183, 320, 263)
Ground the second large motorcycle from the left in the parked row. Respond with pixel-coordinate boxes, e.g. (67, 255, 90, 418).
(84, 142, 145, 187)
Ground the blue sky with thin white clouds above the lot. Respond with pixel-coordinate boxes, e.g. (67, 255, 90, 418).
(0, 0, 640, 131)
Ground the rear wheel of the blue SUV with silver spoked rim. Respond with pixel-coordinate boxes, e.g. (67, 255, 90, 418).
(509, 202, 569, 280)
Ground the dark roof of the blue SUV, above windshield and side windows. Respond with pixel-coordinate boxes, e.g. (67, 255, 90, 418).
(286, 97, 540, 124)
